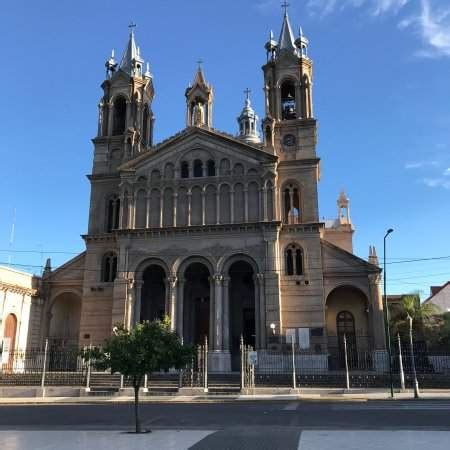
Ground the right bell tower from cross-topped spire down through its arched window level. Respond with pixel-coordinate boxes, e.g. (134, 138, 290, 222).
(262, 2, 320, 226)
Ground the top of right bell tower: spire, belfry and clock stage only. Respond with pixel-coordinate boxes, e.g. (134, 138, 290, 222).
(263, 2, 316, 160)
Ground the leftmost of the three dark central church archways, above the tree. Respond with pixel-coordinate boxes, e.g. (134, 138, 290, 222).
(140, 264, 166, 322)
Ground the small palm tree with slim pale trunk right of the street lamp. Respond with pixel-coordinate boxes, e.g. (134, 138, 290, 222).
(393, 294, 436, 398)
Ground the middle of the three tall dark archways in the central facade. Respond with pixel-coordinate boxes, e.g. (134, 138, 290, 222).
(183, 262, 211, 345)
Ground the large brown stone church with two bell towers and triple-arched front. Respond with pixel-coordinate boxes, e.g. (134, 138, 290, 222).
(41, 13, 385, 371)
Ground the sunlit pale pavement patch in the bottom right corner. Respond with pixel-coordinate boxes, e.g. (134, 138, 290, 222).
(298, 430, 450, 450)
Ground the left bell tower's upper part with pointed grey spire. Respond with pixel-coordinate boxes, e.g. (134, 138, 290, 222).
(94, 24, 154, 173)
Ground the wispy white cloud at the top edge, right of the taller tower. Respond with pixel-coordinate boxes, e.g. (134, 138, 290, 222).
(307, 0, 411, 16)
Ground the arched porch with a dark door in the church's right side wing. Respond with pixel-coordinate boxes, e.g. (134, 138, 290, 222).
(326, 286, 371, 366)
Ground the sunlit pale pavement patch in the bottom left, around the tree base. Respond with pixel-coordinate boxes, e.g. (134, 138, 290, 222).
(0, 430, 214, 450)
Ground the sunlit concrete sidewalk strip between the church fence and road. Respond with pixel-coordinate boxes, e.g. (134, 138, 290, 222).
(0, 388, 450, 405)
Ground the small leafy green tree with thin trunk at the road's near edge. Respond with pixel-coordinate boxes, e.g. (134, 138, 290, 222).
(83, 318, 192, 433)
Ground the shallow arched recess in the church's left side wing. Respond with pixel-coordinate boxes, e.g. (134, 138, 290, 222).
(48, 292, 81, 349)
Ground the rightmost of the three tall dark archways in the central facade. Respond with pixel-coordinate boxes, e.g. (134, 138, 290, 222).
(228, 261, 256, 370)
